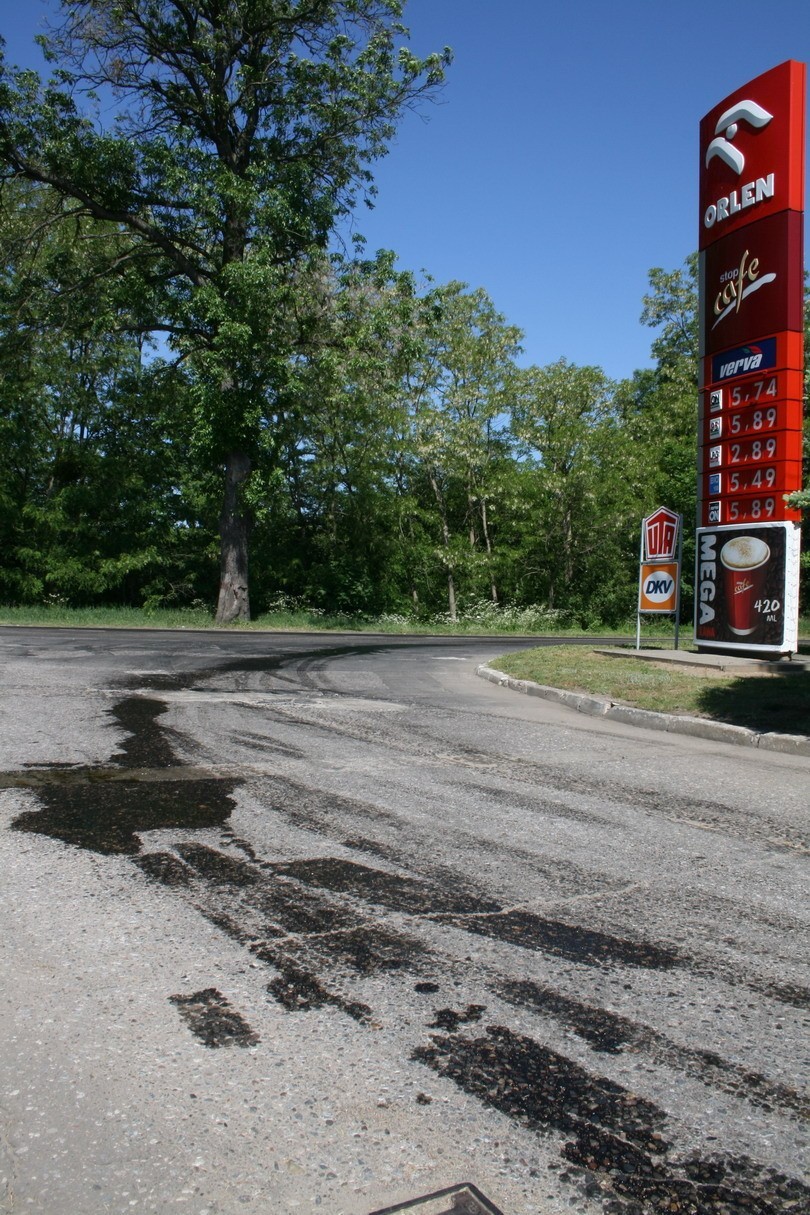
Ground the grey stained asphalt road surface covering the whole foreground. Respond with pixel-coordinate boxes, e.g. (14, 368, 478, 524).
(0, 628, 810, 1215)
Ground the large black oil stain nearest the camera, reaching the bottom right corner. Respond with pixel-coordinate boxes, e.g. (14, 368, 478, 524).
(414, 1025, 810, 1215)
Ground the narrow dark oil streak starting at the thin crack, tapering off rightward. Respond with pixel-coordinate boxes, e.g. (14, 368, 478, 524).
(431, 911, 682, 970)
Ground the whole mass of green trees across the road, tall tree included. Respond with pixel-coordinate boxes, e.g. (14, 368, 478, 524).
(0, 0, 806, 622)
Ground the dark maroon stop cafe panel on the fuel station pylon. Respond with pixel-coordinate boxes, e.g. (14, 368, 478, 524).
(701, 211, 804, 355)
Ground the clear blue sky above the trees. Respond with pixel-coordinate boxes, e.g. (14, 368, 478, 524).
(0, 0, 810, 378)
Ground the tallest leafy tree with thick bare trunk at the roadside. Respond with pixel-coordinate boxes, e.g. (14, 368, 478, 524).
(0, 0, 449, 622)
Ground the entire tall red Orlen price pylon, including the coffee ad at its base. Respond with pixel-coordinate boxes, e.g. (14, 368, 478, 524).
(695, 61, 805, 652)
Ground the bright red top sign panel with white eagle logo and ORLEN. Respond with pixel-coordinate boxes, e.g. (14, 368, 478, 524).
(699, 60, 805, 249)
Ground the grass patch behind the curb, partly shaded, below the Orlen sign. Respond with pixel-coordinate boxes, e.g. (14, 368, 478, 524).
(491, 645, 810, 734)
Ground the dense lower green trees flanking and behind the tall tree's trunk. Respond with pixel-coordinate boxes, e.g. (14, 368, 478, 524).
(0, 198, 709, 620)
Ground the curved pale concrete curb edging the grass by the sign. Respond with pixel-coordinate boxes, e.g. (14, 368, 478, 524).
(475, 666, 810, 756)
